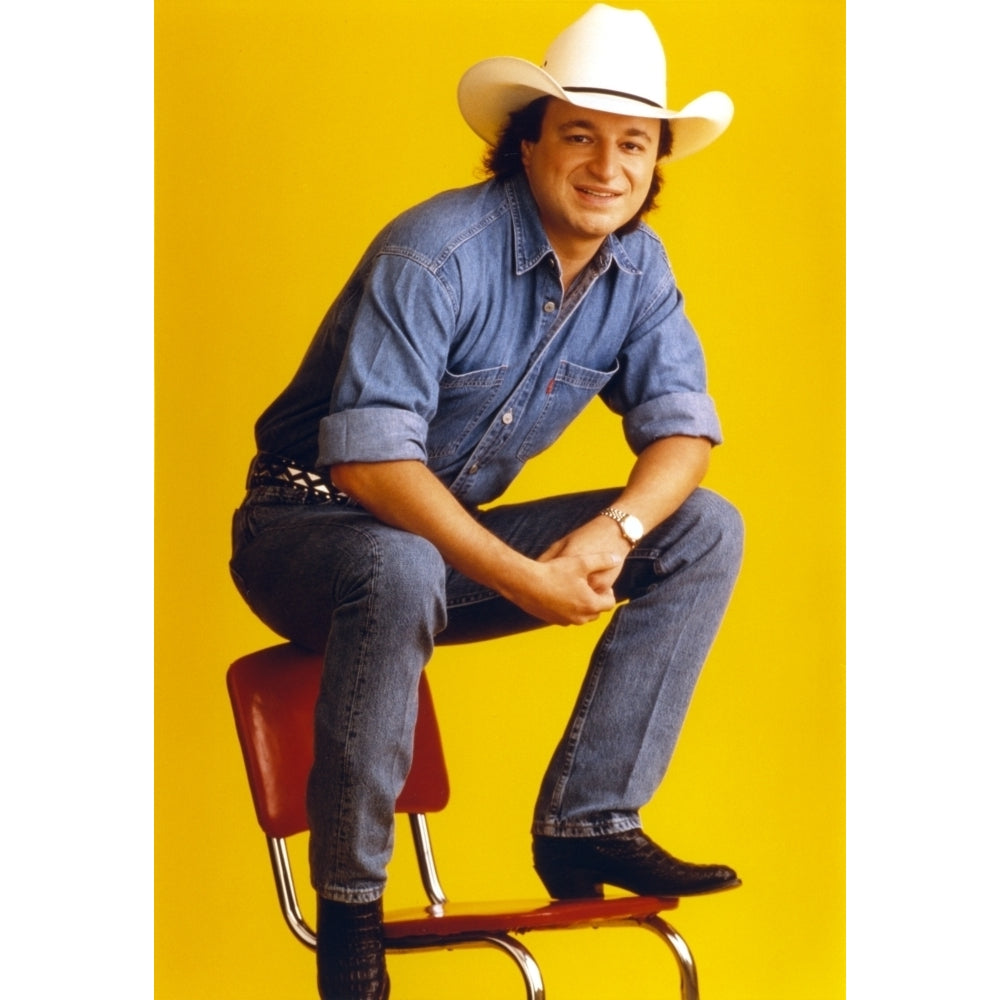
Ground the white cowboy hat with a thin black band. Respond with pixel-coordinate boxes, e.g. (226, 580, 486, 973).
(458, 3, 733, 160)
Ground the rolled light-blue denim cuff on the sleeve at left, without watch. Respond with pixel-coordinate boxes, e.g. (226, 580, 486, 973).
(316, 408, 427, 468)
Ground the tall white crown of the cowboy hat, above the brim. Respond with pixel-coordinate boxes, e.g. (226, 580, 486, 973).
(542, 4, 667, 110)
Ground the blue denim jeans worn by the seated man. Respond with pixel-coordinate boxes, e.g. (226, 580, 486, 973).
(231, 486, 743, 903)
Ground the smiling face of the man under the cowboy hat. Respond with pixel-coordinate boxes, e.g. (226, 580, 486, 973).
(521, 98, 660, 256)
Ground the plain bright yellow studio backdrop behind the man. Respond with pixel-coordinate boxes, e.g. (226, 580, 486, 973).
(155, 0, 845, 1000)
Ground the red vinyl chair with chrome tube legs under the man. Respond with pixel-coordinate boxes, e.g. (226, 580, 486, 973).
(226, 644, 698, 1000)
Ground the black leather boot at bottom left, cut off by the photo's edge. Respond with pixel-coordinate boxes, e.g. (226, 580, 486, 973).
(316, 896, 389, 1000)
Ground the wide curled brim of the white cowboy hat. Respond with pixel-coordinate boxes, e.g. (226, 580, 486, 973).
(458, 56, 733, 161)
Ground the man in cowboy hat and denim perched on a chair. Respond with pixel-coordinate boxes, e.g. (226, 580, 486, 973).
(231, 5, 742, 1000)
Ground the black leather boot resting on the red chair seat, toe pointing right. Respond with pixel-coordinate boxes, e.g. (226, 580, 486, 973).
(534, 830, 741, 899)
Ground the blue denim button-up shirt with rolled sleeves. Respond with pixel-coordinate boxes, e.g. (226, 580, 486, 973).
(250, 175, 721, 505)
